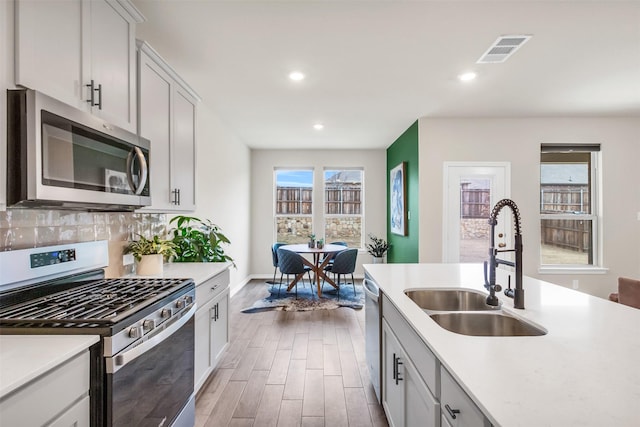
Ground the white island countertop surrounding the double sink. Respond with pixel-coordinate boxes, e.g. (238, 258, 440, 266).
(365, 264, 640, 427)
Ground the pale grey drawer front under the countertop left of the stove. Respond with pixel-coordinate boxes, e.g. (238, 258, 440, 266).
(0, 351, 89, 426)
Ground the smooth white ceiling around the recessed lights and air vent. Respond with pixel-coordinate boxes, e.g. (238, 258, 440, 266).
(134, 0, 640, 149)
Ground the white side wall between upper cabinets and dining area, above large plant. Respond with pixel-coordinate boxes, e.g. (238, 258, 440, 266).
(188, 103, 251, 291)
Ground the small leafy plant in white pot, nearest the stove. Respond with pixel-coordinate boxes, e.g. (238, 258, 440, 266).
(124, 235, 176, 276)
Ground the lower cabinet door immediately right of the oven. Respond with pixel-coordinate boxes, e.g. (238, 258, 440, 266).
(193, 301, 215, 392)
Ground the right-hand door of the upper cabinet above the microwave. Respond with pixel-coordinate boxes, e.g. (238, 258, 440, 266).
(87, 0, 137, 133)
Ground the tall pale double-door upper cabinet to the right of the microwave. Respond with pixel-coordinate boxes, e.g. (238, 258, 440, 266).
(138, 41, 198, 212)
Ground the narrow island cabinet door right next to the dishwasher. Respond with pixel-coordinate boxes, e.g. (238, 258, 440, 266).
(382, 320, 405, 427)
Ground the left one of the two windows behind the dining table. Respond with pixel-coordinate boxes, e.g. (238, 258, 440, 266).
(275, 169, 313, 243)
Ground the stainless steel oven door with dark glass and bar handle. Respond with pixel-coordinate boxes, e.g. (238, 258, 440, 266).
(106, 305, 196, 427)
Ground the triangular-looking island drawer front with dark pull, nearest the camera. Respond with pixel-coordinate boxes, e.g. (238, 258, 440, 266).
(440, 368, 490, 427)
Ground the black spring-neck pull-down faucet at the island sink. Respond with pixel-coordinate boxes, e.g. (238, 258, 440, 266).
(484, 199, 524, 309)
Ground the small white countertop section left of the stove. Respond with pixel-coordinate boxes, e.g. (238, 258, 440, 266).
(0, 335, 99, 398)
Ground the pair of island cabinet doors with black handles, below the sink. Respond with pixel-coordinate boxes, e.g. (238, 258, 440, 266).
(382, 321, 440, 427)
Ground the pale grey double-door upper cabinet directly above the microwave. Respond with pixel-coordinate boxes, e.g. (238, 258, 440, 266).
(15, 0, 144, 132)
